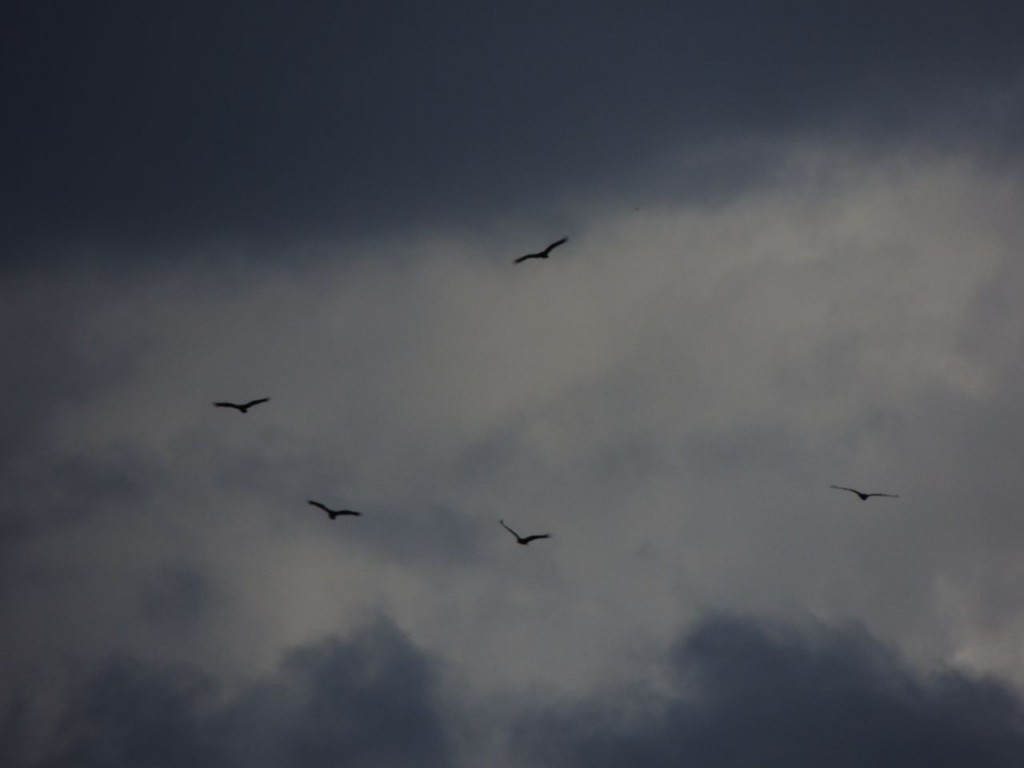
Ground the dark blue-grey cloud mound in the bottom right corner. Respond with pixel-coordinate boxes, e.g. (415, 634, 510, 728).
(520, 617, 1024, 768)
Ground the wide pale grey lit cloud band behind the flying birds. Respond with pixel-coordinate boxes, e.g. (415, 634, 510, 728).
(0, 100, 1024, 764)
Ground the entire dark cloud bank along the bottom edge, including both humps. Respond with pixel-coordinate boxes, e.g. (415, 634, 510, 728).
(14, 614, 1024, 768)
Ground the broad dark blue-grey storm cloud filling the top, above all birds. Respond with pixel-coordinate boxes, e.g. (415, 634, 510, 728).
(6, 1, 1024, 253)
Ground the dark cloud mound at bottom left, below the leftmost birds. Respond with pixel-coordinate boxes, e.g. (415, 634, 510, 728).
(23, 624, 452, 768)
